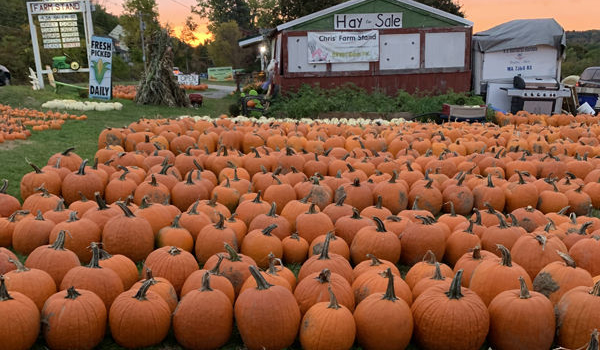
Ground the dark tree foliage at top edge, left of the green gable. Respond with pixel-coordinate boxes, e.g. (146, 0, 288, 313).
(192, 0, 252, 32)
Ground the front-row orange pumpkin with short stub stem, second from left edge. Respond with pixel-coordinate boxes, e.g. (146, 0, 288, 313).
(42, 287, 107, 349)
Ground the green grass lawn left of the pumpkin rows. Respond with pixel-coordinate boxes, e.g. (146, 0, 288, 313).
(0, 86, 235, 198)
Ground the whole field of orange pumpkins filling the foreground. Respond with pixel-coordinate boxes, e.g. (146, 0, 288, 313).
(0, 113, 600, 349)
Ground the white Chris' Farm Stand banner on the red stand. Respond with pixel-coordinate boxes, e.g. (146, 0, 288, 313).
(307, 30, 379, 63)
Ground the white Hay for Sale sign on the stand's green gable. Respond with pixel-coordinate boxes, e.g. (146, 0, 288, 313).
(333, 12, 402, 30)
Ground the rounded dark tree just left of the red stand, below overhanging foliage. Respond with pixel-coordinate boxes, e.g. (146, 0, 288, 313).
(208, 21, 254, 68)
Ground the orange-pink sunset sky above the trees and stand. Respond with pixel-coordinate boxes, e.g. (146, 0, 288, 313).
(103, 0, 600, 42)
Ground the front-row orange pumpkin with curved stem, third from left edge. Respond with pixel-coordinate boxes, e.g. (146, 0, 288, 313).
(108, 281, 171, 348)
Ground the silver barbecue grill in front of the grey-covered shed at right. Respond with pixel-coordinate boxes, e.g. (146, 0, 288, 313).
(505, 75, 571, 115)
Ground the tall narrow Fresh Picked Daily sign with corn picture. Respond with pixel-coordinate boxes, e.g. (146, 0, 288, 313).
(89, 35, 113, 100)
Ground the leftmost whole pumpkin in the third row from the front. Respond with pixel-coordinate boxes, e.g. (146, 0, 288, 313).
(12, 210, 56, 255)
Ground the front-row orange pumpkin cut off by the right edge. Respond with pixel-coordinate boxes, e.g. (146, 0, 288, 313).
(556, 282, 600, 349)
